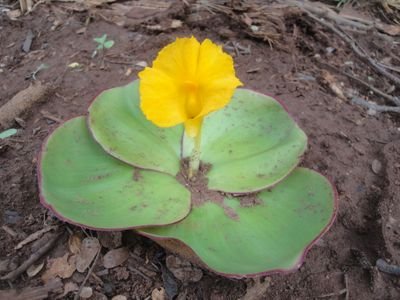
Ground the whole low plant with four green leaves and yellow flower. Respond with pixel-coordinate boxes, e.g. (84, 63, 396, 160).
(39, 38, 337, 277)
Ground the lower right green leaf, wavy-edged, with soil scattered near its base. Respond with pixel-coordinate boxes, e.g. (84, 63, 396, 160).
(139, 168, 337, 277)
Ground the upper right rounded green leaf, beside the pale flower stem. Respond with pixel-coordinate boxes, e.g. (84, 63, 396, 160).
(183, 89, 307, 193)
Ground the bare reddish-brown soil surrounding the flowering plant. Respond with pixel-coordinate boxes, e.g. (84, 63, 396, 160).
(0, 1, 400, 299)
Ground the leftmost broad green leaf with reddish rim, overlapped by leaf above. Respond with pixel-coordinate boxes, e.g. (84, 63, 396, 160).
(39, 117, 190, 229)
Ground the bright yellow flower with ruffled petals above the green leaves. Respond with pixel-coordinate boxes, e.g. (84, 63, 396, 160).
(139, 37, 242, 137)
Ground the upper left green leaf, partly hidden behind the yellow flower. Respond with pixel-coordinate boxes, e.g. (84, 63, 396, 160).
(89, 81, 183, 176)
